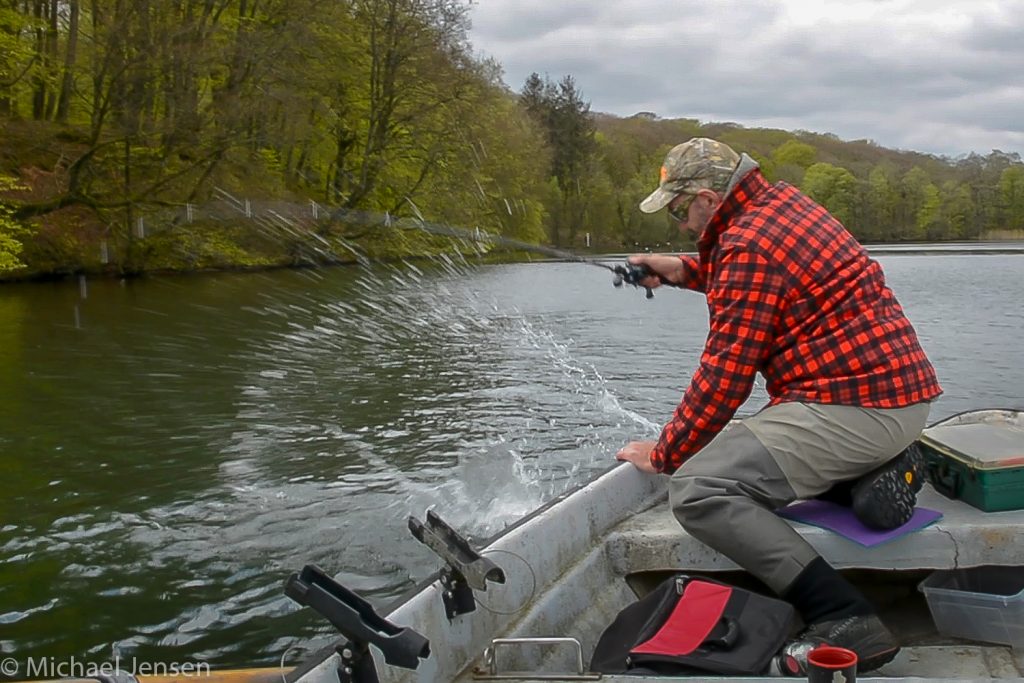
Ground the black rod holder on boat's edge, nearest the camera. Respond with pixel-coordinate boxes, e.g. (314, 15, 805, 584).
(285, 564, 430, 683)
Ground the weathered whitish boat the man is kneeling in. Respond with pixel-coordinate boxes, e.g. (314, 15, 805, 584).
(289, 409, 1024, 683)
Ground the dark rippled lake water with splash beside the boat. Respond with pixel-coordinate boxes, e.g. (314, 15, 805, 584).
(0, 252, 1024, 667)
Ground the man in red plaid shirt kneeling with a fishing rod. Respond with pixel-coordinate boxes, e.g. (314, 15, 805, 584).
(616, 138, 941, 675)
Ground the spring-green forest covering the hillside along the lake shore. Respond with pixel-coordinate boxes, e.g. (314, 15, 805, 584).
(0, 0, 1024, 274)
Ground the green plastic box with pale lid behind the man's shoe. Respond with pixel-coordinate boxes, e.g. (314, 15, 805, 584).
(918, 410, 1024, 512)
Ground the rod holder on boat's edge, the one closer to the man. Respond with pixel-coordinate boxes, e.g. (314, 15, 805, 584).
(409, 510, 505, 620)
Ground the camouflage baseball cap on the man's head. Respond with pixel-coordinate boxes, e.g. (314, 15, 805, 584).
(640, 137, 739, 213)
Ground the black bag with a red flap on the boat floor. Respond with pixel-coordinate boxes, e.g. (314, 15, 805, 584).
(590, 574, 796, 675)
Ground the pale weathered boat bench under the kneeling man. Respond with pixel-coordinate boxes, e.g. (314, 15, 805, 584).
(605, 486, 1024, 575)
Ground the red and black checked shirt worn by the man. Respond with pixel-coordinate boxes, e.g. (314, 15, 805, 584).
(650, 170, 942, 473)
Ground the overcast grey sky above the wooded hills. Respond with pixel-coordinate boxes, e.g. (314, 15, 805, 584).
(470, 0, 1024, 156)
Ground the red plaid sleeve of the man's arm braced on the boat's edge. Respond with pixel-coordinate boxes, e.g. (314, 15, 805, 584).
(650, 248, 784, 473)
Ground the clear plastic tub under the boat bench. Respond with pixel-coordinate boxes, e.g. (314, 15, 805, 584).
(919, 566, 1024, 649)
